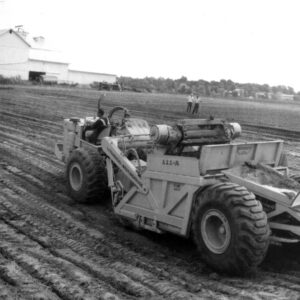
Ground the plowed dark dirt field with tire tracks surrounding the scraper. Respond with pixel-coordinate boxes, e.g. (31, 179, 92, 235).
(0, 87, 300, 300)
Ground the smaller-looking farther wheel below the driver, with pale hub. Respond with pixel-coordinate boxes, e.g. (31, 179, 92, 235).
(66, 149, 108, 203)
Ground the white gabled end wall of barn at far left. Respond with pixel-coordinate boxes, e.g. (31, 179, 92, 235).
(0, 31, 29, 80)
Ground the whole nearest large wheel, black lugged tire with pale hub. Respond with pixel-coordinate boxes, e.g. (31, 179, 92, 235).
(192, 183, 270, 275)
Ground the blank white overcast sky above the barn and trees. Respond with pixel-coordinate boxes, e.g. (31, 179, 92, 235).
(0, 0, 300, 91)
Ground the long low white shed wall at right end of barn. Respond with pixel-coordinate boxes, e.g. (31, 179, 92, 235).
(68, 70, 117, 84)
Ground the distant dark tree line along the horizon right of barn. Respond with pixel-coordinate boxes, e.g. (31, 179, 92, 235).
(118, 76, 300, 97)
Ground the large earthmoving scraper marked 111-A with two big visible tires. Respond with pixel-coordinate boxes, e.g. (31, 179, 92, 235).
(58, 109, 300, 274)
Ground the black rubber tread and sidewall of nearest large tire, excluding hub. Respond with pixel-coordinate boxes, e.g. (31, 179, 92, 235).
(192, 182, 270, 275)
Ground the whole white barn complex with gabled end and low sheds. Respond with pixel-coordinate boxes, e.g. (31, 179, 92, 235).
(0, 28, 117, 85)
